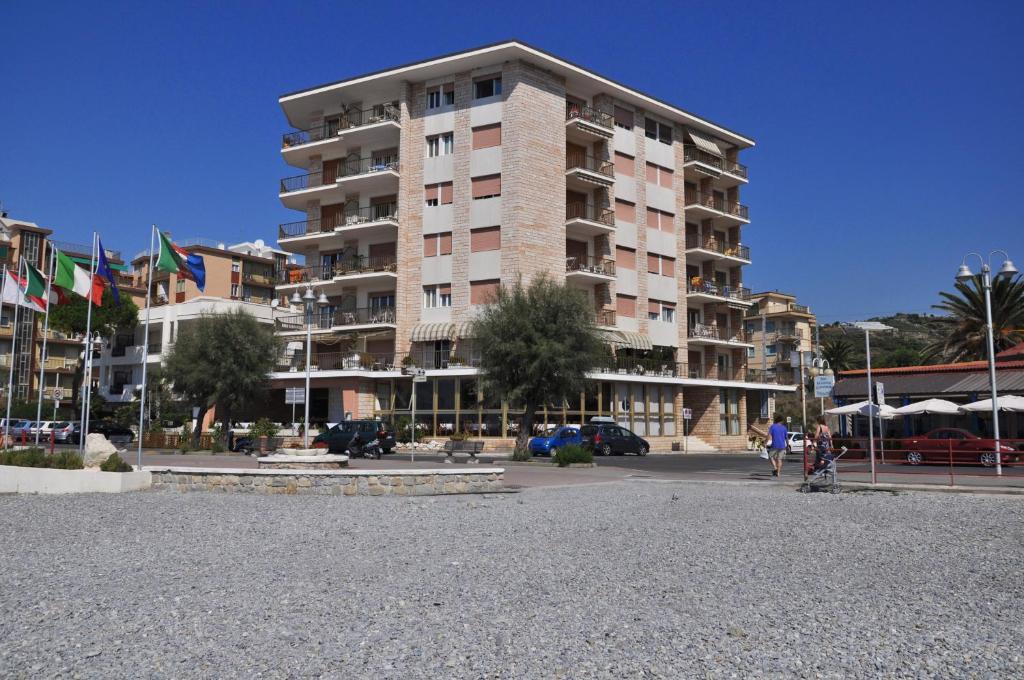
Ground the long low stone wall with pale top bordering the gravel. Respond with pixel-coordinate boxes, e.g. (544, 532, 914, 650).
(147, 467, 505, 496)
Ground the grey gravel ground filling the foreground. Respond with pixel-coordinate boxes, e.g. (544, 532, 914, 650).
(0, 481, 1024, 678)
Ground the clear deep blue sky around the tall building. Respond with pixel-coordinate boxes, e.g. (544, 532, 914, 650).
(0, 0, 1024, 321)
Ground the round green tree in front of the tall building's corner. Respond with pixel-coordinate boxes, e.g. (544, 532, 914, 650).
(473, 275, 608, 458)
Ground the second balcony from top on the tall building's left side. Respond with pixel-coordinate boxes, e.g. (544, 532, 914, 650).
(280, 154, 399, 210)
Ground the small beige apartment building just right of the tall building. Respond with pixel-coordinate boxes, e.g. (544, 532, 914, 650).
(743, 291, 817, 384)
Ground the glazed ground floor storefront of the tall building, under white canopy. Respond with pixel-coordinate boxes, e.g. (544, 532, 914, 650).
(271, 370, 774, 449)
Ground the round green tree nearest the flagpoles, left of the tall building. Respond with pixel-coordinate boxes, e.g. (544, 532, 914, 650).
(164, 310, 279, 447)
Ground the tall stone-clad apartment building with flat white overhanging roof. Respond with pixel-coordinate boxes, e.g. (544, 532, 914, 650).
(274, 41, 786, 447)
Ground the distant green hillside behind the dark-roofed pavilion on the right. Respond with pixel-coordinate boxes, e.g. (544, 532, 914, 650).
(821, 313, 954, 369)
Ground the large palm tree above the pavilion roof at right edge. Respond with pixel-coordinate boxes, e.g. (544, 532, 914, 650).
(925, 277, 1024, 362)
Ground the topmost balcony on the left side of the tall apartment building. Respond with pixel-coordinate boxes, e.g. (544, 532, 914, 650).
(281, 104, 401, 167)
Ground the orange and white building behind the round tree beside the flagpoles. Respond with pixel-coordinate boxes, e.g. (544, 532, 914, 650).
(94, 239, 291, 403)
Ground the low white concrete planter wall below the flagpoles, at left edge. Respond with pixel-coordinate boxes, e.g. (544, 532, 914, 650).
(0, 465, 153, 494)
